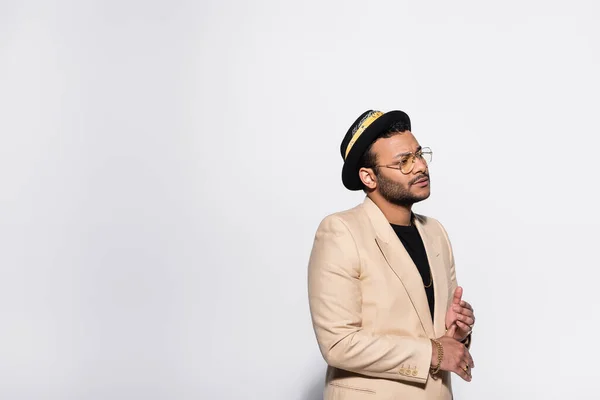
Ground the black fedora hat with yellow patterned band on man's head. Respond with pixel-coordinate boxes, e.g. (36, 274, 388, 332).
(340, 110, 411, 190)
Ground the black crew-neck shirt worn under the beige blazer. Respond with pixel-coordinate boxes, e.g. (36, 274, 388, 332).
(390, 224, 435, 320)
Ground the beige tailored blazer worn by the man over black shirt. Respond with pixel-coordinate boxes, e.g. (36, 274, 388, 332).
(308, 197, 457, 400)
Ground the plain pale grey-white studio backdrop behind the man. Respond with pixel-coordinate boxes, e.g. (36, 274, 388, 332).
(0, 0, 600, 400)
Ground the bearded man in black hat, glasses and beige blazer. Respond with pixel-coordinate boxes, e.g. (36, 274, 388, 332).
(308, 110, 475, 400)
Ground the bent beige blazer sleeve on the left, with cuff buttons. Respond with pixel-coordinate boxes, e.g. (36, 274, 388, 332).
(308, 215, 432, 383)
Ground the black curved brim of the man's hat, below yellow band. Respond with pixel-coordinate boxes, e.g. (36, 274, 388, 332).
(342, 110, 410, 190)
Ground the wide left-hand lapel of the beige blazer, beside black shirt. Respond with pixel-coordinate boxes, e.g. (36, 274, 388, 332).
(363, 197, 437, 337)
